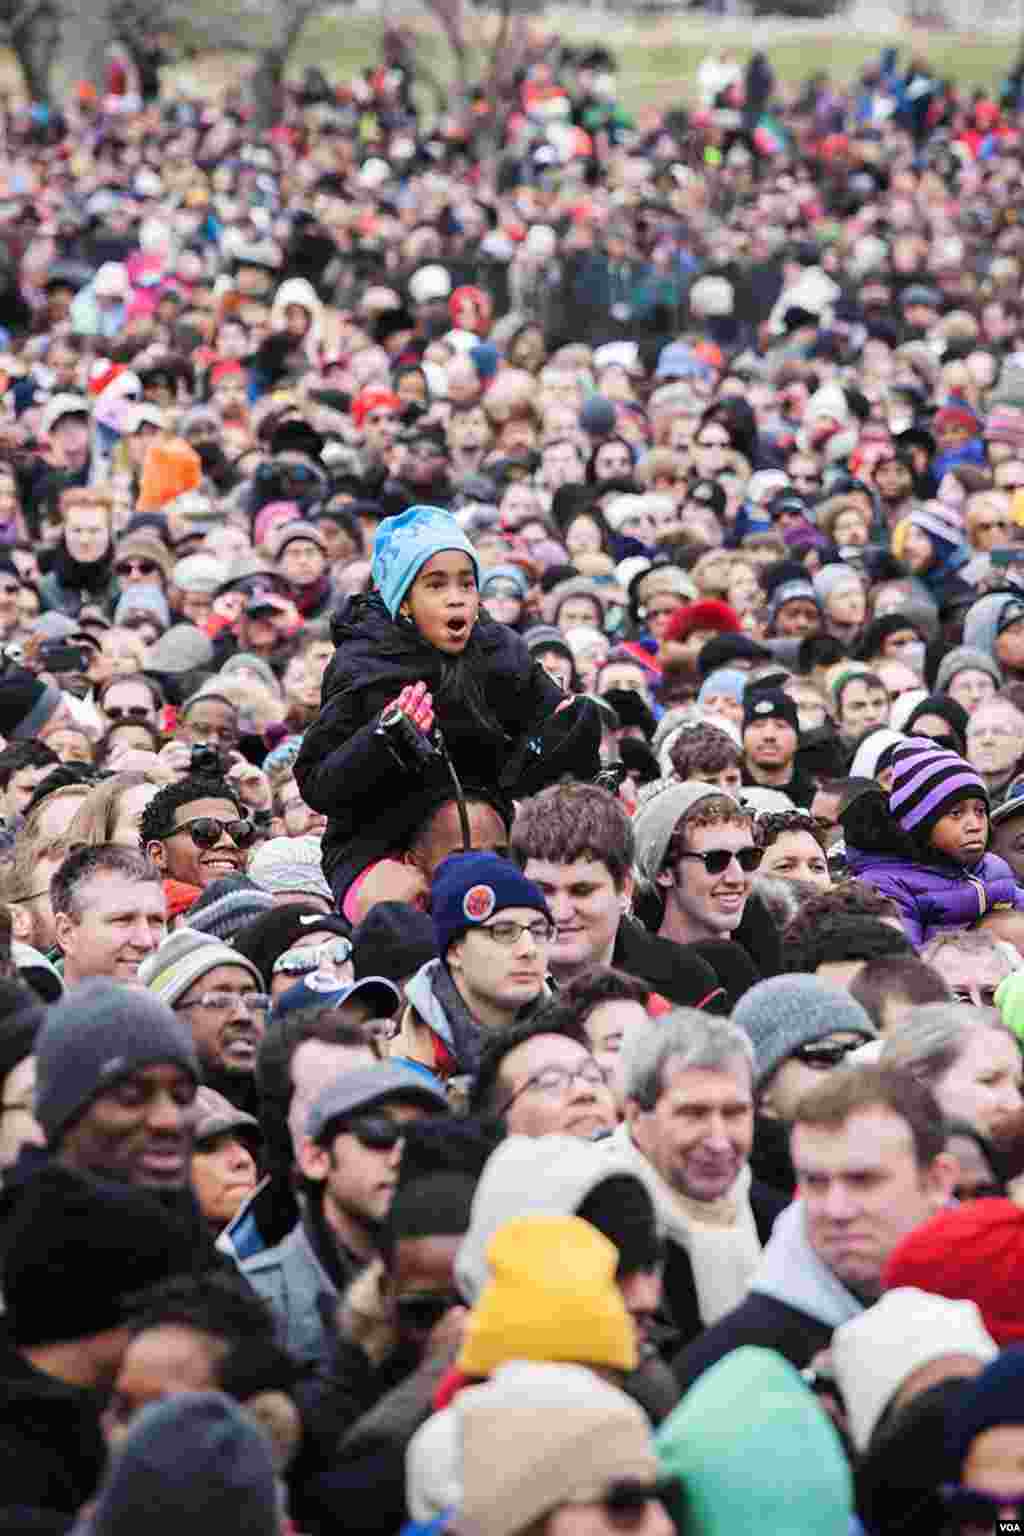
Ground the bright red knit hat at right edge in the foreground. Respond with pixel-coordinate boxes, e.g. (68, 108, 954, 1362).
(883, 1200, 1024, 1347)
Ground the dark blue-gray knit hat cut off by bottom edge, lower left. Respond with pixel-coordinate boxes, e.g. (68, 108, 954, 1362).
(89, 1392, 281, 1536)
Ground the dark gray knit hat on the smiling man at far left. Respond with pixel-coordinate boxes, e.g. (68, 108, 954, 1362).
(35, 977, 200, 1147)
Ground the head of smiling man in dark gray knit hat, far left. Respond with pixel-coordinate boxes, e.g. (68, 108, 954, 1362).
(35, 978, 200, 1190)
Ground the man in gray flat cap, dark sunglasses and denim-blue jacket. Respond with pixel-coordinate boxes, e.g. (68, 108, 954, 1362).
(241, 1061, 447, 1366)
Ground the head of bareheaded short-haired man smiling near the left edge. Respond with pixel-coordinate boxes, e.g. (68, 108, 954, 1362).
(51, 843, 167, 986)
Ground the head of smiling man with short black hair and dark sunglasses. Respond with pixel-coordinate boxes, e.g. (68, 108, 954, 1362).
(140, 777, 255, 894)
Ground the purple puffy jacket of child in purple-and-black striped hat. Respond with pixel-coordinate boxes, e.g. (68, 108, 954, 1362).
(846, 843, 1024, 949)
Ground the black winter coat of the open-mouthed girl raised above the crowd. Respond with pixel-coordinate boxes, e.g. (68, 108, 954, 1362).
(295, 593, 600, 903)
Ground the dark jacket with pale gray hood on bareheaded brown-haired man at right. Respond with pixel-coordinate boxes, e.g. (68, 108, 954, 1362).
(672, 1200, 864, 1392)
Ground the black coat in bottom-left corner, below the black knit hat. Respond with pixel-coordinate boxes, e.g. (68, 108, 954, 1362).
(0, 1338, 106, 1531)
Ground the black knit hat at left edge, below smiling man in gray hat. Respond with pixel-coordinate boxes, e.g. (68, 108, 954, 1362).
(3, 1163, 195, 1347)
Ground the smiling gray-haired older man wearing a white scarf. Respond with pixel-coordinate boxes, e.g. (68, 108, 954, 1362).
(608, 1009, 785, 1339)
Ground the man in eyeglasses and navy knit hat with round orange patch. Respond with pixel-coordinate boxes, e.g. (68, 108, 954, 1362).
(391, 852, 554, 1078)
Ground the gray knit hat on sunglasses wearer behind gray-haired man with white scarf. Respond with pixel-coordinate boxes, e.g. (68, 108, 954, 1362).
(732, 975, 875, 1087)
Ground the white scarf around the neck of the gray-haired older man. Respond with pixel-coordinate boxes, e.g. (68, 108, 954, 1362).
(599, 1124, 761, 1329)
